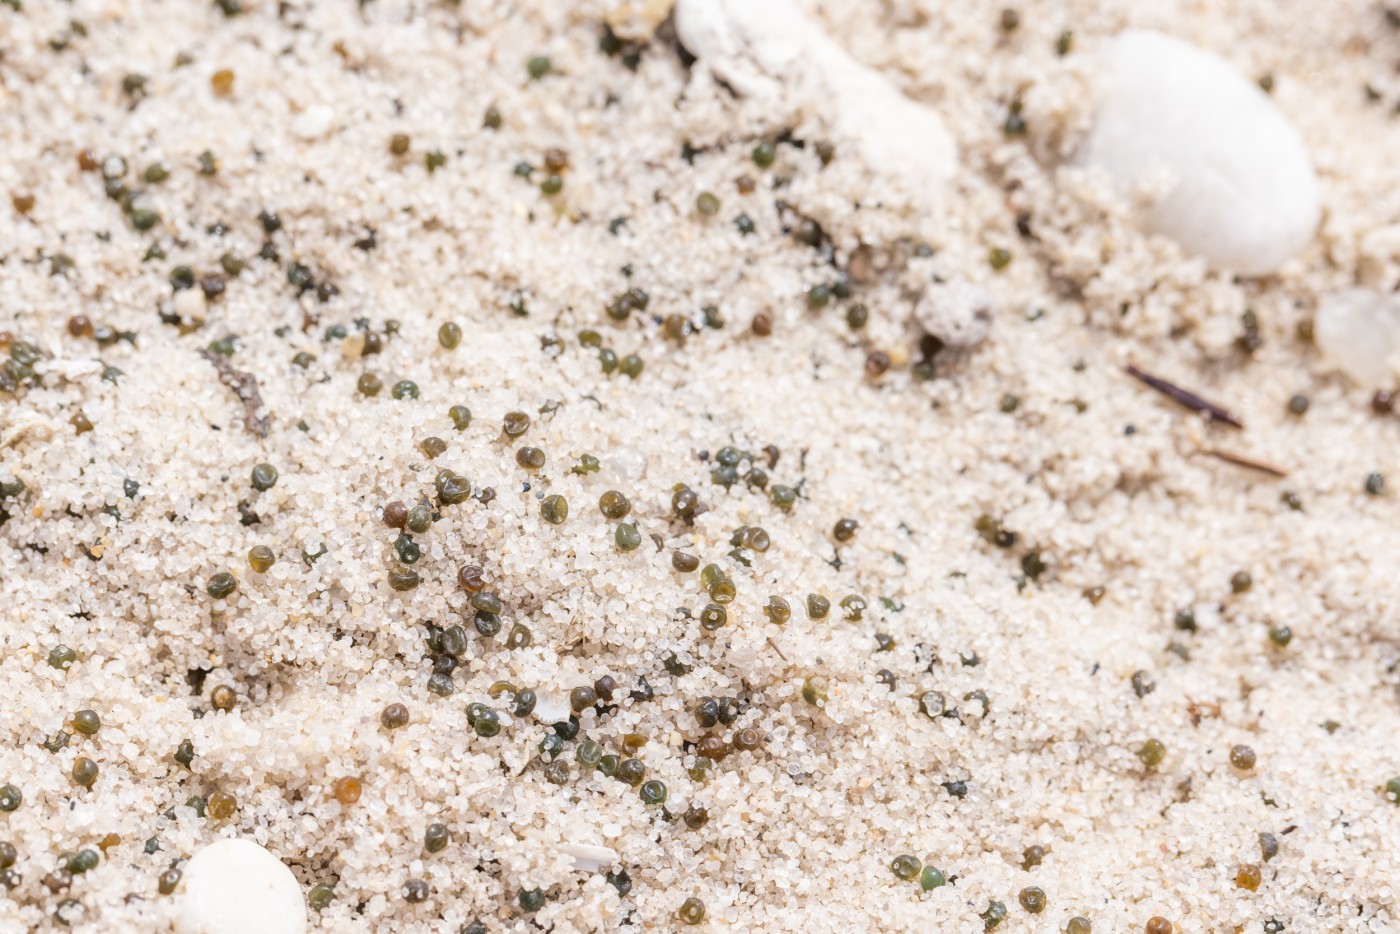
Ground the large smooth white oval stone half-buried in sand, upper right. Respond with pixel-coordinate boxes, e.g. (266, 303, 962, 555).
(1081, 29, 1320, 276)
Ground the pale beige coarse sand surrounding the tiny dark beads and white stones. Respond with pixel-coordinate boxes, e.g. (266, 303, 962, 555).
(0, 0, 1400, 933)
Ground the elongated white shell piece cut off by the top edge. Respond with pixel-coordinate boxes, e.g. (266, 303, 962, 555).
(675, 0, 958, 183)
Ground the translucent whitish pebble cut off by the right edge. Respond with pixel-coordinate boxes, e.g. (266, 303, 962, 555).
(1313, 288, 1400, 389)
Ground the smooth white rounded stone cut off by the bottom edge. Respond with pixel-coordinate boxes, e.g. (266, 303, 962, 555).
(175, 839, 307, 934)
